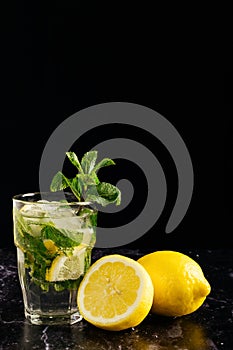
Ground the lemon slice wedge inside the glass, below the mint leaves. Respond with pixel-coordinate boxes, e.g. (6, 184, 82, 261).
(46, 245, 86, 282)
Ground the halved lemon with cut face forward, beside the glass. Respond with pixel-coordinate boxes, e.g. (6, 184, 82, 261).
(77, 254, 154, 331)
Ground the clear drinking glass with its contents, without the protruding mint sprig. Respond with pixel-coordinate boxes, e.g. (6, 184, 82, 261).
(13, 192, 97, 325)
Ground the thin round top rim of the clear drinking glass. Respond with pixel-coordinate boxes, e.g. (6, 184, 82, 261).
(12, 191, 93, 206)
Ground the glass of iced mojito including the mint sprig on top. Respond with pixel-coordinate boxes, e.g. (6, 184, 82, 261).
(13, 150, 121, 325)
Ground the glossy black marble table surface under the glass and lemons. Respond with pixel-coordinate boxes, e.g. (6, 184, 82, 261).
(0, 248, 233, 350)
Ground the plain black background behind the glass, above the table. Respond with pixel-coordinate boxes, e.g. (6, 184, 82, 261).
(0, 1, 233, 250)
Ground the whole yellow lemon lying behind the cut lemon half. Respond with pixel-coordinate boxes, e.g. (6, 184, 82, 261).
(138, 250, 211, 316)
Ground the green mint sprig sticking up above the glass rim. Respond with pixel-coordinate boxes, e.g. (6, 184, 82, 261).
(50, 151, 121, 206)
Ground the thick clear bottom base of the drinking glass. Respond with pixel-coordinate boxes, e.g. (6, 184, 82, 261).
(25, 310, 82, 326)
